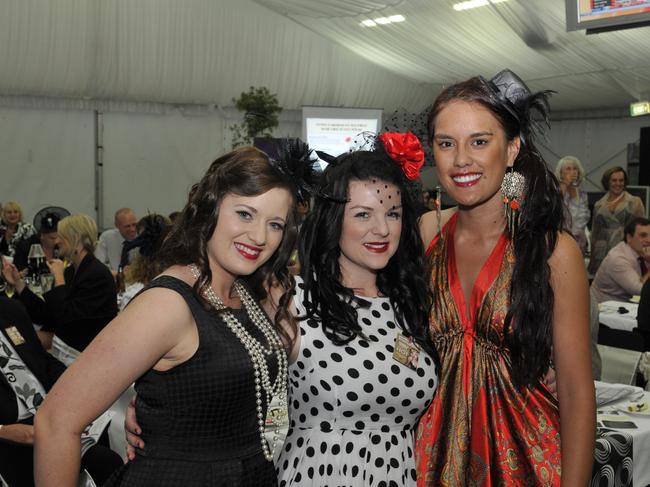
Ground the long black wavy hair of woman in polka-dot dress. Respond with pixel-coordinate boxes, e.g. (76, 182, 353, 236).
(299, 149, 437, 360)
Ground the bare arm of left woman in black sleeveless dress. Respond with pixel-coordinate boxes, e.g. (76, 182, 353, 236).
(34, 288, 192, 487)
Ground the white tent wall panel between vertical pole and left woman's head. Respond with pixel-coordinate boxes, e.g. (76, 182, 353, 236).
(98, 113, 224, 226)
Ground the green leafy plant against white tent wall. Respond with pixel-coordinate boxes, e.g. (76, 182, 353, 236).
(230, 86, 282, 149)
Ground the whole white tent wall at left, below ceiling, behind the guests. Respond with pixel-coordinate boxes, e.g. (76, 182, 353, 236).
(0, 106, 301, 228)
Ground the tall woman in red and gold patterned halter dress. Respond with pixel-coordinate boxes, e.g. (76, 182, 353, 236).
(416, 71, 595, 487)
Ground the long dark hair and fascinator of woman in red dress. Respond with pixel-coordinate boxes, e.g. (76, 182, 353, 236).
(428, 77, 564, 386)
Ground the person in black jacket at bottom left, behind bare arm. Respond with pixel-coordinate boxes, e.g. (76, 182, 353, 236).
(0, 297, 122, 487)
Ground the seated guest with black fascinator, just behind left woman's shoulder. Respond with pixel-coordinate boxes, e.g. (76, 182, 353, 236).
(118, 213, 171, 311)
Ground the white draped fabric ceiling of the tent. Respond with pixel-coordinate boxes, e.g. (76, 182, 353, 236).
(0, 0, 650, 111)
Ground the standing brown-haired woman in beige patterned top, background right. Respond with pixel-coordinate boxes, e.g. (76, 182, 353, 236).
(588, 166, 645, 275)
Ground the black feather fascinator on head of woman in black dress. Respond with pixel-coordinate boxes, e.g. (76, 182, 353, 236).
(271, 138, 320, 202)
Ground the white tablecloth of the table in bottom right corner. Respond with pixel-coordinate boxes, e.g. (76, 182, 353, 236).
(599, 391, 650, 487)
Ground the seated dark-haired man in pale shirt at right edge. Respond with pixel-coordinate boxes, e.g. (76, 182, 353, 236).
(591, 217, 650, 303)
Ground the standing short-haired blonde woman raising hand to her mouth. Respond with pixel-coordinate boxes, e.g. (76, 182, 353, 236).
(555, 156, 591, 255)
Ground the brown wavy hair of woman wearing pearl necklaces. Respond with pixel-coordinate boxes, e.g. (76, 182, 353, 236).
(159, 147, 296, 342)
